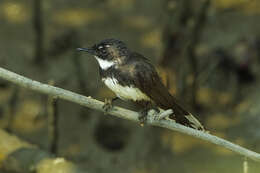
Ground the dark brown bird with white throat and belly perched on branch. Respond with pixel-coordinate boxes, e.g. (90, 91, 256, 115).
(77, 38, 204, 131)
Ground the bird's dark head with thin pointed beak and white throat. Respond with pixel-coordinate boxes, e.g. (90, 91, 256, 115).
(77, 39, 129, 70)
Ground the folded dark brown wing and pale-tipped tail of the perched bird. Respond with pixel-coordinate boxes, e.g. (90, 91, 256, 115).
(130, 54, 203, 129)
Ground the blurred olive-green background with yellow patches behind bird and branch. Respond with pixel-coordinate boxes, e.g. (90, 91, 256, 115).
(0, 0, 260, 173)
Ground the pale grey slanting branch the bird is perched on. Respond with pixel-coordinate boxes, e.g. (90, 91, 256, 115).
(0, 68, 260, 162)
